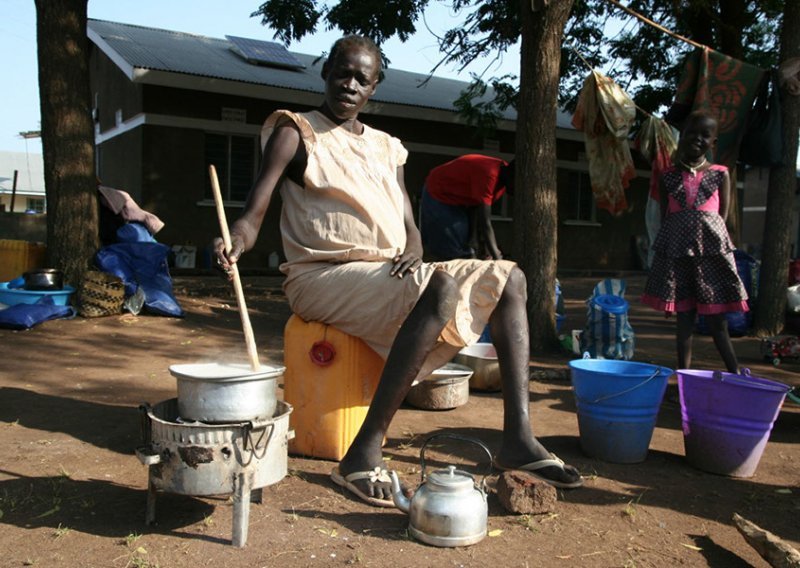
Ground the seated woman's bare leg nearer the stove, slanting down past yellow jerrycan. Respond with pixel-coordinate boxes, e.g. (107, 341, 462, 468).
(339, 270, 458, 499)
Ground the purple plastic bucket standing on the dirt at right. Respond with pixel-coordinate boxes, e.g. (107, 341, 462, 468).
(676, 369, 790, 477)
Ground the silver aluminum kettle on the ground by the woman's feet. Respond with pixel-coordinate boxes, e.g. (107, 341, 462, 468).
(389, 434, 492, 547)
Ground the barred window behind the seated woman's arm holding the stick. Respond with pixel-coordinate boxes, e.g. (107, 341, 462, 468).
(205, 133, 258, 201)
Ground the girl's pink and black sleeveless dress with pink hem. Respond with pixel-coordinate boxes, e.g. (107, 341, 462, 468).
(642, 165, 748, 314)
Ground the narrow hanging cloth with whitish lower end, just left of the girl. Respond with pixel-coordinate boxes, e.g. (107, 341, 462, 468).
(633, 116, 678, 267)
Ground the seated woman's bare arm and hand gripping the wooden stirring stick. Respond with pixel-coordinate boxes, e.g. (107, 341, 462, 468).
(213, 124, 306, 270)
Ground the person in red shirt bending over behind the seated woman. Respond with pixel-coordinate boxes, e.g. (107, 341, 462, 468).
(420, 154, 514, 260)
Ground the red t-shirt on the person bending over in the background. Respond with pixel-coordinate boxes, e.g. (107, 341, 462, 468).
(425, 154, 506, 206)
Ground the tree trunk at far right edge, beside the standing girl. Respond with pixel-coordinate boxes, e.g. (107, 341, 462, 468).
(754, 2, 800, 337)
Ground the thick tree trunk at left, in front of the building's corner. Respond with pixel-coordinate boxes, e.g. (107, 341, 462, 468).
(36, 0, 99, 285)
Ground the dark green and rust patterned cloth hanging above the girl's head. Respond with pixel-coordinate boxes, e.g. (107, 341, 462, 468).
(666, 47, 765, 170)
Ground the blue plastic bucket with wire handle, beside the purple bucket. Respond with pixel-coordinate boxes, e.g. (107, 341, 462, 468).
(569, 359, 673, 463)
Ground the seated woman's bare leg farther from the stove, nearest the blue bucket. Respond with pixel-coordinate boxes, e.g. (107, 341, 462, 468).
(489, 268, 580, 483)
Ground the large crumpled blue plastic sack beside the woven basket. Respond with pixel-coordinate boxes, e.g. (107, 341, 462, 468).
(94, 242, 184, 317)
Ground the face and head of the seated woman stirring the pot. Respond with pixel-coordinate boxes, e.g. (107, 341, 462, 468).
(324, 45, 380, 120)
